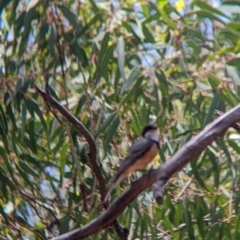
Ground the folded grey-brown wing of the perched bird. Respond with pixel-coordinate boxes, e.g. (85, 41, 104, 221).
(112, 137, 153, 183)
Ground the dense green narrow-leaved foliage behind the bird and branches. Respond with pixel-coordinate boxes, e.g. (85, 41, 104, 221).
(0, 0, 240, 239)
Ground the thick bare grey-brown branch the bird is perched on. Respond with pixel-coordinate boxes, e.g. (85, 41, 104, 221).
(51, 105, 240, 240)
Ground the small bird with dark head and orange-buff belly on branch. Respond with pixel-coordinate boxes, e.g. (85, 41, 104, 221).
(103, 123, 160, 203)
